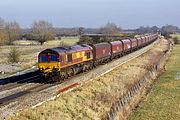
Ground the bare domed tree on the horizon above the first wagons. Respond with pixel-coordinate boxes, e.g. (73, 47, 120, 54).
(101, 22, 121, 35)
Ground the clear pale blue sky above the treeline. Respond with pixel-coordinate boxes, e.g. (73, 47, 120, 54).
(0, 0, 180, 29)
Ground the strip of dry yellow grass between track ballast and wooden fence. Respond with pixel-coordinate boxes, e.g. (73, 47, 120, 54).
(6, 40, 167, 120)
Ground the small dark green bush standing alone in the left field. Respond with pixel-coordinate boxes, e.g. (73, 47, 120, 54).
(8, 47, 20, 63)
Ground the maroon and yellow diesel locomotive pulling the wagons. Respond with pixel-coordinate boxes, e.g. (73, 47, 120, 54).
(38, 45, 93, 79)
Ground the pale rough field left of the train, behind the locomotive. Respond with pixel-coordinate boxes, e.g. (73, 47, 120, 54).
(0, 37, 79, 77)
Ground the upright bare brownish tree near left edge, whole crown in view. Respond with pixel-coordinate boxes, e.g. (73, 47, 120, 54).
(5, 22, 21, 45)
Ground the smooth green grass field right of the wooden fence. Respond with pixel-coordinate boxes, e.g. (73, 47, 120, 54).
(130, 45, 180, 120)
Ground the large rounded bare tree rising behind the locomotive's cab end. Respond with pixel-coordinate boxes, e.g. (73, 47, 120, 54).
(32, 20, 55, 45)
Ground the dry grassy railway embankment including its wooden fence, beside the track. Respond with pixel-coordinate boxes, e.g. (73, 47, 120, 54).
(6, 39, 171, 120)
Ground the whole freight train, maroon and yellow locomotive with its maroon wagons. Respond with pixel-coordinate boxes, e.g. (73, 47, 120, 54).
(38, 34, 158, 80)
